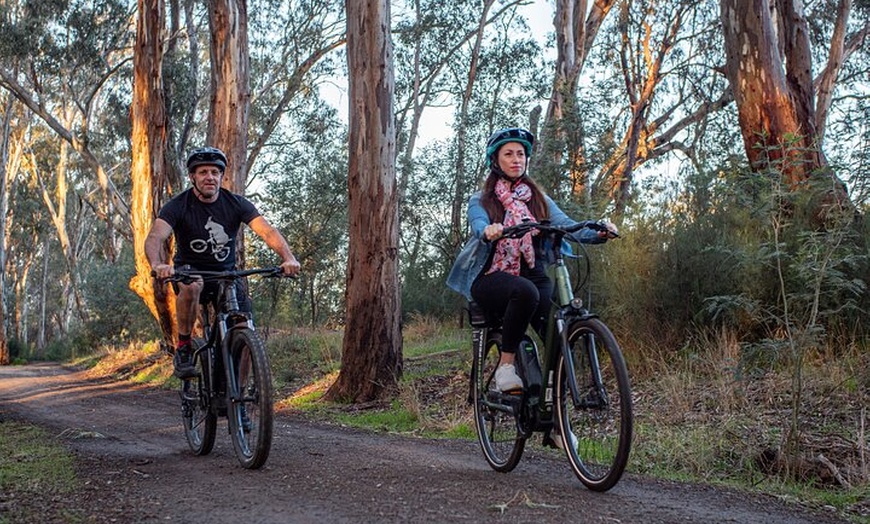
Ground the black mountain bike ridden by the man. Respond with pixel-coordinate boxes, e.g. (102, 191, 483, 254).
(158, 267, 283, 469)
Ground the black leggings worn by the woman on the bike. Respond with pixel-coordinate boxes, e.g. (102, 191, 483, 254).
(471, 261, 553, 353)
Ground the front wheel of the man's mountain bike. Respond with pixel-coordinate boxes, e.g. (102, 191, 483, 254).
(227, 328, 273, 469)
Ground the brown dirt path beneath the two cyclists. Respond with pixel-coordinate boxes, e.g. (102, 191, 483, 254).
(0, 364, 844, 524)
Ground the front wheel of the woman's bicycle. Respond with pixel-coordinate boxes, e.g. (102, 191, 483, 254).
(556, 318, 634, 491)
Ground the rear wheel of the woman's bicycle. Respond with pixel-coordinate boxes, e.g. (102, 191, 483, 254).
(471, 334, 526, 473)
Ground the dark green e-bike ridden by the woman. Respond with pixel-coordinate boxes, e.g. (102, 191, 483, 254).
(469, 221, 633, 491)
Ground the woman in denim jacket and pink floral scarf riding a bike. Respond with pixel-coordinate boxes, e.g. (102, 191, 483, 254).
(447, 127, 617, 398)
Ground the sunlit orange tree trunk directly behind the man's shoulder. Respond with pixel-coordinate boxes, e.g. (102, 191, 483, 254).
(129, 0, 177, 347)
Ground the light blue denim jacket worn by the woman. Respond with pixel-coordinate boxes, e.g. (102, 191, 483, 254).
(447, 191, 605, 300)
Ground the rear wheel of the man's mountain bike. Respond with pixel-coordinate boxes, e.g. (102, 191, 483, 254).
(181, 341, 217, 455)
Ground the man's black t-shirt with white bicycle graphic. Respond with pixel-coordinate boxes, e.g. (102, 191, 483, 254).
(157, 188, 260, 271)
